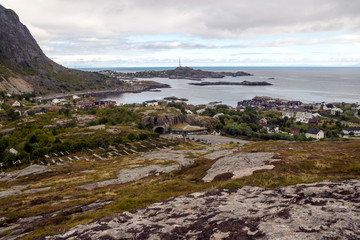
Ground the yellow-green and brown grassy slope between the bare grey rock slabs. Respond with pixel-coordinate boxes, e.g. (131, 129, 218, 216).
(0, 140, 360, 239)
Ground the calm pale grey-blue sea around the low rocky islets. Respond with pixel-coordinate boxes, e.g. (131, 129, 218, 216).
(79, 67, 360, 106)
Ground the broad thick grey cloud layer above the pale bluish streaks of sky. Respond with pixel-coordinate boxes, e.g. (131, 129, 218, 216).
(3, 0, 360, 39)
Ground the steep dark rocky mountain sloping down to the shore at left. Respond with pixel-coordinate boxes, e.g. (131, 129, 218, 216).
(0, 5, 115, 94)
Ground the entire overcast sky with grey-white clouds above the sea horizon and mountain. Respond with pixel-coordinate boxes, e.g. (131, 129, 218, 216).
(0, 0, 360, 67)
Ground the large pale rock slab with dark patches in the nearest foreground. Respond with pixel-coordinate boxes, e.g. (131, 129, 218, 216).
(47, 180, 360, 239)
